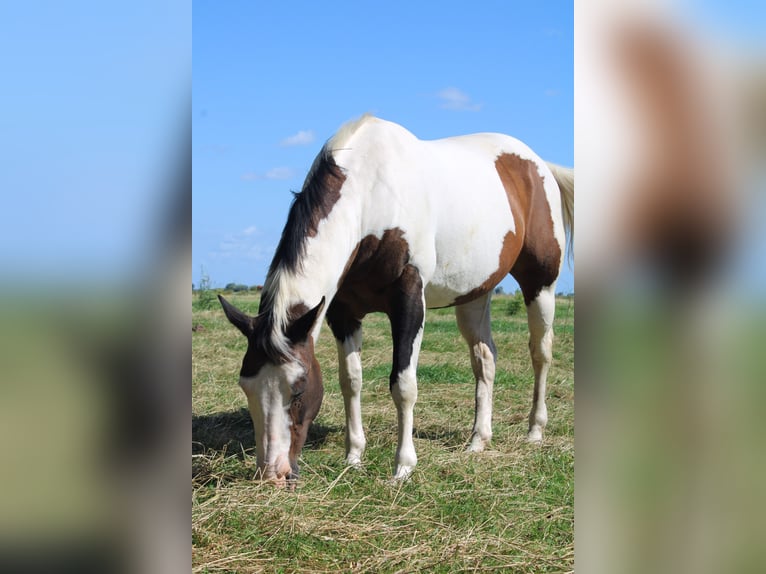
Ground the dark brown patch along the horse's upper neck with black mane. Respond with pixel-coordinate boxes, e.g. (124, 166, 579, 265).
(269, 155, 346, 275)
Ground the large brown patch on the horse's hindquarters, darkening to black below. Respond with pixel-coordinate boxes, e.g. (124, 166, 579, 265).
(495, 153, 561, 305)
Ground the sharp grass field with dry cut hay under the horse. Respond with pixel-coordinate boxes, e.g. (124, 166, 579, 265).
(192, 294, 574, 573)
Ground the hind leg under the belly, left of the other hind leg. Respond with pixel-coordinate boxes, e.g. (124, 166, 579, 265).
(455, 293, 497, 452)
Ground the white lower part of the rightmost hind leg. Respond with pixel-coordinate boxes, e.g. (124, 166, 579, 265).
(527, 283, 556, 442)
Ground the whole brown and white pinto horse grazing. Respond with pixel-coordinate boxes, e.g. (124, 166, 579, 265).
(220, 115, 574, 484)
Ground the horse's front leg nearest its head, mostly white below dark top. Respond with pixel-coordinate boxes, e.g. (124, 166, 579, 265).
(327, 301, 367, 466)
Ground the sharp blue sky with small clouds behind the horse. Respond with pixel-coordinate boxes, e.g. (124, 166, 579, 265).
(192, 1, 574, 292)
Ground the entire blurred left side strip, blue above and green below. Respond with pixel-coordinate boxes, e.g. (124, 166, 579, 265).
(0, 0, 192, 572)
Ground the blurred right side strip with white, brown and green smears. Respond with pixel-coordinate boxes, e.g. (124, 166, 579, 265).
(575, 1, 766, 573)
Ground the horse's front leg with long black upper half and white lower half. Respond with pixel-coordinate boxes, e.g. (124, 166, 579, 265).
(388, 265, 425, 480)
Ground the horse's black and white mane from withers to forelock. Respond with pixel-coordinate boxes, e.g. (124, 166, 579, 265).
(254, 114, 375, 363)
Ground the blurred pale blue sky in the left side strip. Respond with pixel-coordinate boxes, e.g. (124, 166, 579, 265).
(0, 0, 192, 284)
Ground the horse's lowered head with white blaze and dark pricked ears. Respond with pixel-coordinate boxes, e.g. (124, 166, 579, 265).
(218, 295, 325, 486)
